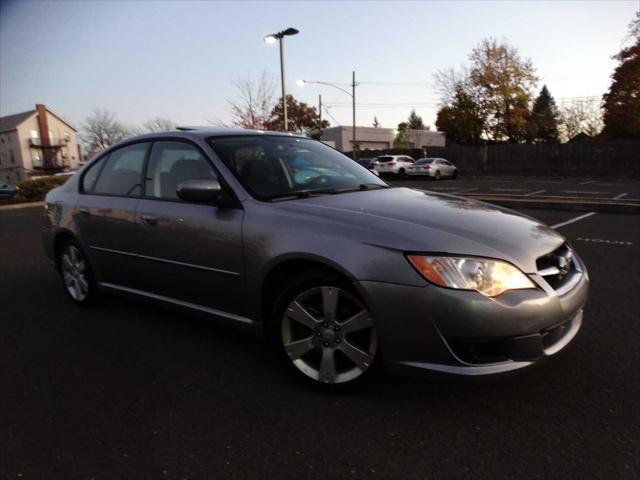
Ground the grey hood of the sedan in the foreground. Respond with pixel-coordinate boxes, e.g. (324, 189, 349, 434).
(277, 188, 564, 273)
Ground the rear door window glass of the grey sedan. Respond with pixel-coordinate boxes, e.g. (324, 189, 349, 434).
(93, 143, 149, 196)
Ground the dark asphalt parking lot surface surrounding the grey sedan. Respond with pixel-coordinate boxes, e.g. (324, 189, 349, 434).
(0, 204, 640, 479)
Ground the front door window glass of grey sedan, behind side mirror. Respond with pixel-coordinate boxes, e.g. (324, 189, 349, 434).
(145, 141, 216, 200)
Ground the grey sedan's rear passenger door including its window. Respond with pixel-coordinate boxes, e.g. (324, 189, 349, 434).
(75, 142, 150, 286)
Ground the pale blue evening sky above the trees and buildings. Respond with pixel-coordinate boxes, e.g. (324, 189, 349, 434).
(0, 0, 640, 128)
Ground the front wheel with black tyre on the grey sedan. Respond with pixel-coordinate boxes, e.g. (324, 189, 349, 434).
(272, 272, 378, 389)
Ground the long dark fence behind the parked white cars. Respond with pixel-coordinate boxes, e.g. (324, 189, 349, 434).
(350, 140, 640, 174)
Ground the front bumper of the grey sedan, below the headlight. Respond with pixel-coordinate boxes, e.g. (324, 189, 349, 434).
(356, 256, 589, 375)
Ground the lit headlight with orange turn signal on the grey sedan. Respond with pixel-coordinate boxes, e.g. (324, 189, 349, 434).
(408, 255, 536, 297)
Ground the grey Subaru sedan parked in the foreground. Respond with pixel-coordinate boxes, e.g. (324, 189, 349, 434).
(43, 128, 588, 389)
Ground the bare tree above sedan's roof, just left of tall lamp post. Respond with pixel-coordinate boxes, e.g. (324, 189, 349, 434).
(210, 72, 275, 130)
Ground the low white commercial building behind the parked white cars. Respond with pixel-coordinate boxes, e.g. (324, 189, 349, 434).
(321, 126, 446, 152)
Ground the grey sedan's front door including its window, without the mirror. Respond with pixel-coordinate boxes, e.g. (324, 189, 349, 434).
(136, 140, 244, 314)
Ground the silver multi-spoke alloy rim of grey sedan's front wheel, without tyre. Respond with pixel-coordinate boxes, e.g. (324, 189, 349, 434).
(281, 286, 378, 384)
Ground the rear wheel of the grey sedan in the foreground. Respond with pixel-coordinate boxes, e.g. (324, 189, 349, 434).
(58, 240, 97, 305)
